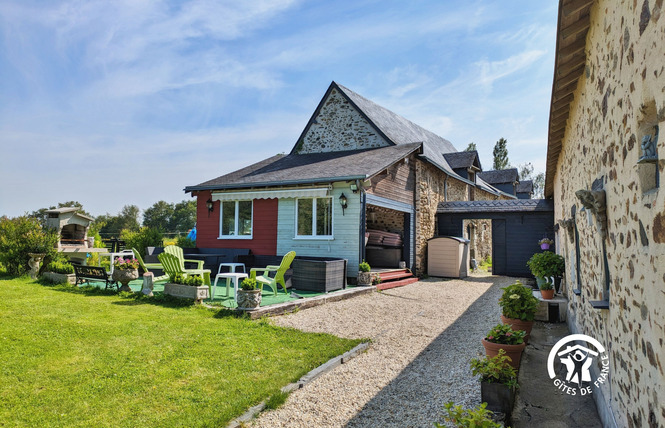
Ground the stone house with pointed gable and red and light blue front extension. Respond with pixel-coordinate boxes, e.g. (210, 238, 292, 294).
(185, 82, 512, 277)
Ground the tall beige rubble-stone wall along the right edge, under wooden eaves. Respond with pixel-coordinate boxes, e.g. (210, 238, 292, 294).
(554, 0, 665, 427)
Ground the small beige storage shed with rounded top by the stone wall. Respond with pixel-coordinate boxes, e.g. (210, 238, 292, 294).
(427, 236, 469, 278)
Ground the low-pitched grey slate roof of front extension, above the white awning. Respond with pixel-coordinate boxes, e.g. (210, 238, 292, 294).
(185, 143, 421, 192)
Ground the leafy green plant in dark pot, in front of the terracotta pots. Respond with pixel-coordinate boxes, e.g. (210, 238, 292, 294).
(471, 349, 518, 417)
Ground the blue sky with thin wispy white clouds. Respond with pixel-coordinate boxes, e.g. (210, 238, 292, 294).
(0, 0, 558, 217)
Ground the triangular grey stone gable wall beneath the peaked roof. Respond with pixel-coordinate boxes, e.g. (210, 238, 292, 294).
(296, 89, 389, 154)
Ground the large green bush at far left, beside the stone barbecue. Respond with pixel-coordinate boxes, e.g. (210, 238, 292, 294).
(0, 216, 59, 275)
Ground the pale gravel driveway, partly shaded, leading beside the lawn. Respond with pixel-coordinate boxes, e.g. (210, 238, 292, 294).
(252, 276, 516, 428)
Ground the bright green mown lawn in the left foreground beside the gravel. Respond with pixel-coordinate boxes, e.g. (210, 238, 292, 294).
(0, 278, 359, 427)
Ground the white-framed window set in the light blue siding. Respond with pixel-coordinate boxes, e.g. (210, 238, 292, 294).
(296, 197, 333, 239)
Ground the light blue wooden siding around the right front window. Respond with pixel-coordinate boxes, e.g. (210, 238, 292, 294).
(277, 183, 361, 277)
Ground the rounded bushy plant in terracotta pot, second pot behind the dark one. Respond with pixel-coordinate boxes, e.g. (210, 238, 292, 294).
(499, 281, 539, 343)
